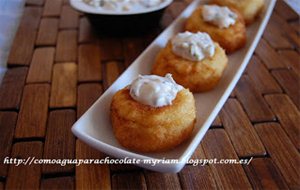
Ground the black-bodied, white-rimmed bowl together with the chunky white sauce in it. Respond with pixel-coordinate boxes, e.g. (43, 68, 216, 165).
(70, 0, 173, 35)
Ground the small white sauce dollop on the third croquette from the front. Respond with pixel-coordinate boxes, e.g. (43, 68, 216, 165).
(202, 5, 237, 28)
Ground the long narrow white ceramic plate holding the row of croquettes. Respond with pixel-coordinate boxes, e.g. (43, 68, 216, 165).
(72, 0, 276, 172)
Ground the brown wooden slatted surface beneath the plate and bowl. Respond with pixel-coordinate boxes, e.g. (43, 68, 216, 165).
(0, 0, 300, 189)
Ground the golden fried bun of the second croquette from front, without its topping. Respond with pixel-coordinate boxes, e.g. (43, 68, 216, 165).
(152, 40, 228, 92)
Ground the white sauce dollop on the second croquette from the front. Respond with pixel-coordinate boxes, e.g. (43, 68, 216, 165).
(172, 32, 215, 61)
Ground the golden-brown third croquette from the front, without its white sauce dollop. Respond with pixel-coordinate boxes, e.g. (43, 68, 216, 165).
(185, 6, 247, 53)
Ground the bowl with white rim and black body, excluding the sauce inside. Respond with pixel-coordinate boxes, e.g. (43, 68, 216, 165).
(70, 0, 173, 35)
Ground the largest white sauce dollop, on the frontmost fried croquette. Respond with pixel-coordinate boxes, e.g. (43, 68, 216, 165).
(129, 74, 183, 107)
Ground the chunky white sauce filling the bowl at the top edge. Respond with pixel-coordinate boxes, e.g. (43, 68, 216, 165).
(82, 0, 165, 12)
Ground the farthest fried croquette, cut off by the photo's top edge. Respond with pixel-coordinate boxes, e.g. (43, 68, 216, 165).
(212, 0, 264, 25)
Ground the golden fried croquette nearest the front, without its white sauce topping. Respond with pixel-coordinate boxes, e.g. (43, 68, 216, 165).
(111, 88, 196, 152)
